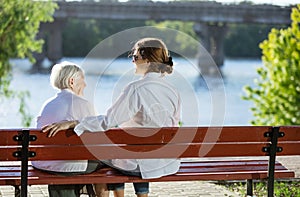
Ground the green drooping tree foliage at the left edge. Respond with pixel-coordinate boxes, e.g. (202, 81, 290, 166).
(0, 0, 57, 126)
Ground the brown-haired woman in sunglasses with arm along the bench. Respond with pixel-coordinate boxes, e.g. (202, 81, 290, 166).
(43, 38, 181, 197)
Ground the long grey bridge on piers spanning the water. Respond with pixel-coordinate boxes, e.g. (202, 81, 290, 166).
(36, 1, 292, 73)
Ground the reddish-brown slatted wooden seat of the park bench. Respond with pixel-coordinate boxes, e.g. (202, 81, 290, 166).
(0, 160, 295, 185)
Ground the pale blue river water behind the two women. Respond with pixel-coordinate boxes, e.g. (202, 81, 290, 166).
(0, 58, 262, 128)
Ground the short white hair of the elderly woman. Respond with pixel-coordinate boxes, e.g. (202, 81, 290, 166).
(50, 62, 84, 90)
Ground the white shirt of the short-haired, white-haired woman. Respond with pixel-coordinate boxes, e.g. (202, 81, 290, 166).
(32, 89, 96, 172)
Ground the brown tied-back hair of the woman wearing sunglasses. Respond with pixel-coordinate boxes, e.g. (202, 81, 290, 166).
(130, 38, 173, 74)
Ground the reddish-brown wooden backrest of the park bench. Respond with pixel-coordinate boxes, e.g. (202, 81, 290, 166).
(0, 126, 300, 161)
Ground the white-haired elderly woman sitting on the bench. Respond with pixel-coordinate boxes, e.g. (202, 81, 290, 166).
(32, 62, 108, 197)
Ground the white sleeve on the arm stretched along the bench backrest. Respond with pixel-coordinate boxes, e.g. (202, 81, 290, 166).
(74, 85, 139, 135)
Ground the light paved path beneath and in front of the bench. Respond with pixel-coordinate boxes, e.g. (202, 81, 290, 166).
(0, 156, 300, 197)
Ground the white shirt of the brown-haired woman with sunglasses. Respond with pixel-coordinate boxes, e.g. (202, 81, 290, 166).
(74, 73, 181, 178)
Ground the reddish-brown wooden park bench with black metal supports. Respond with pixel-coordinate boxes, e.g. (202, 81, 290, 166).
(0, 126, 300, 197)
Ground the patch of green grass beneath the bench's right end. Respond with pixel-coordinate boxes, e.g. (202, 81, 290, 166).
(219, 180, 300, 197)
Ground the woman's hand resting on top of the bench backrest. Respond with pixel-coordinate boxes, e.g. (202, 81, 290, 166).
(42, 120, 79, 137)
